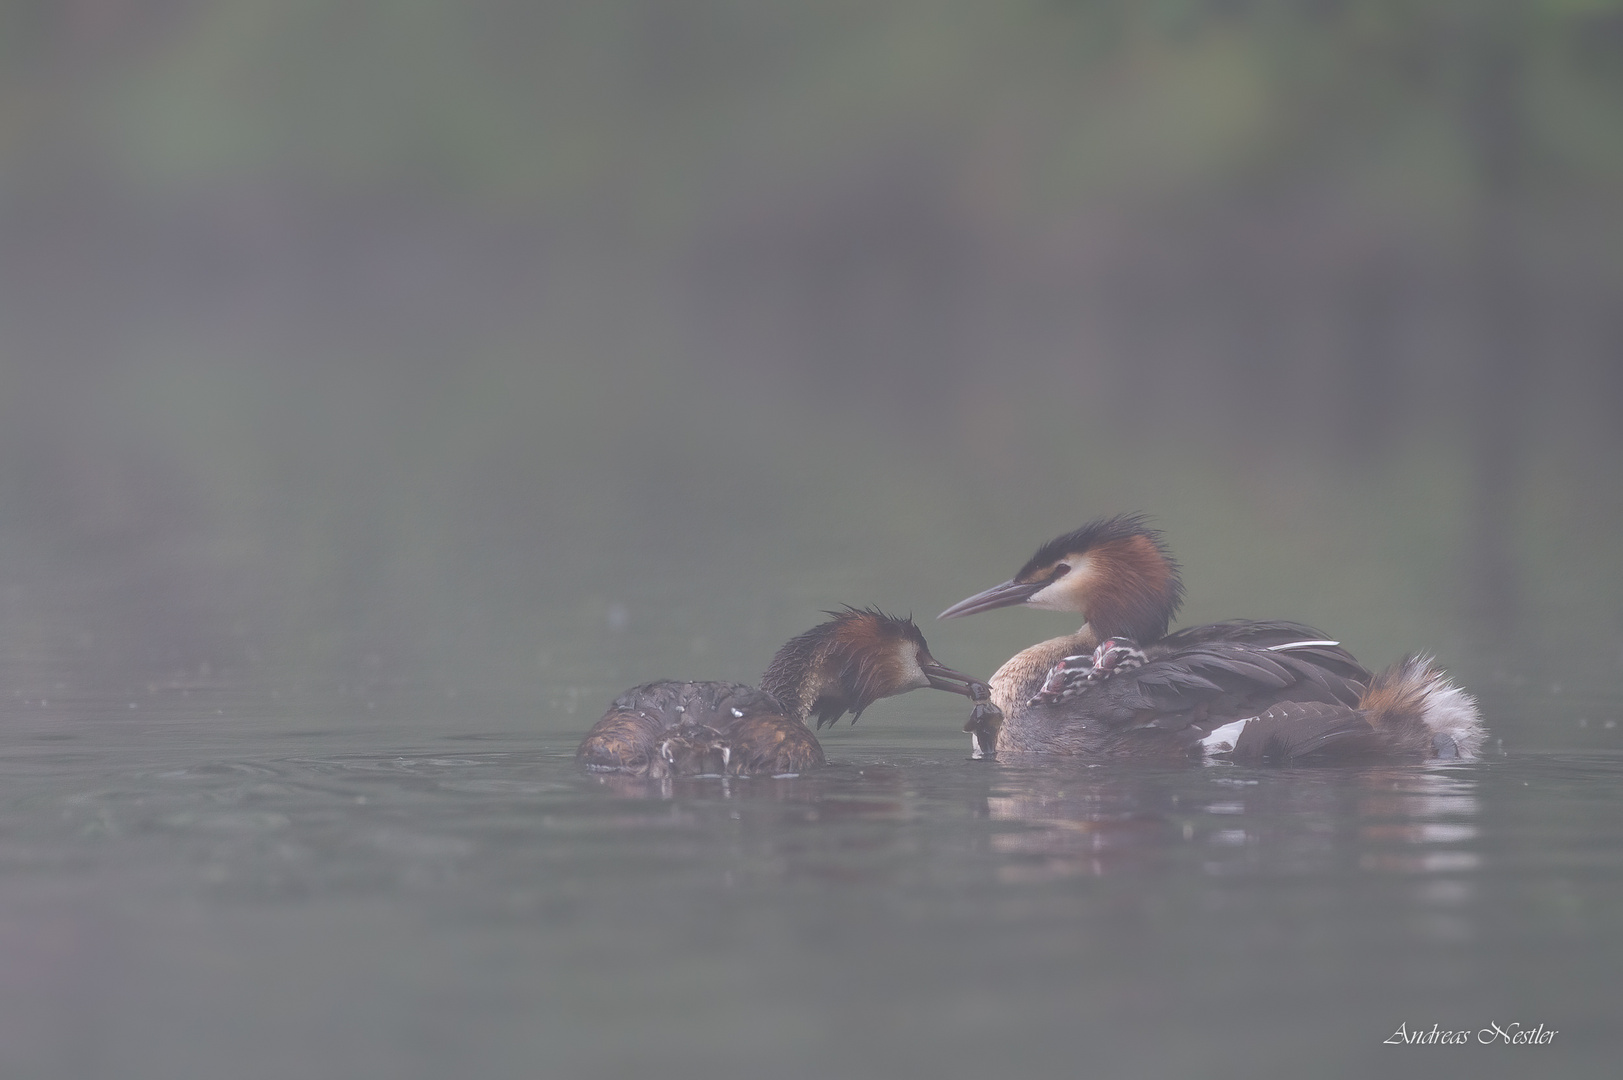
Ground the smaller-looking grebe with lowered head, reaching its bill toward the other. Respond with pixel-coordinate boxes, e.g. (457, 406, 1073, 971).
(575, 607, 987, 778)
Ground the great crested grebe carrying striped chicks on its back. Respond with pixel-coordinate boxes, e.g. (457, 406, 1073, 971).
(940, 515, 1482, 762)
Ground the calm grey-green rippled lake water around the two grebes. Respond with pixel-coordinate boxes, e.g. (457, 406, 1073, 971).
(0, 669, 1623, 1080)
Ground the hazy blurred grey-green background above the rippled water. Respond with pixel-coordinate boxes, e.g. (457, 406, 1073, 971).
(0, 0, 1623, 745)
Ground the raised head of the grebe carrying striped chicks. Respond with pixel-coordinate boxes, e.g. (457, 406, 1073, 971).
(938, 513, 1183, 642)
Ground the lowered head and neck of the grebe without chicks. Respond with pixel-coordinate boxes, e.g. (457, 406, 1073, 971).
(761, 607, 979, 728)
